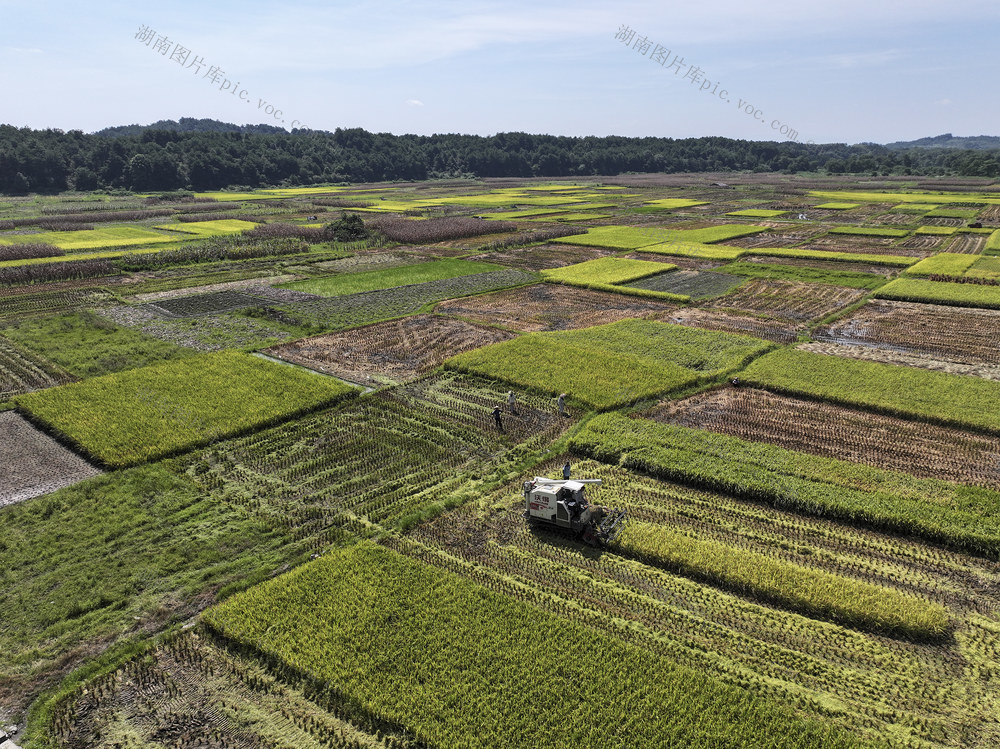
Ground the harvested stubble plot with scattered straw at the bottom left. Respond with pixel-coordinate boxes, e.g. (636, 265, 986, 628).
(54, 631, 402, 749)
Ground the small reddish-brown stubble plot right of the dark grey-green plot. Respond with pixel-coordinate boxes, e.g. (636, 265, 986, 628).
(705, 278, 865, 322)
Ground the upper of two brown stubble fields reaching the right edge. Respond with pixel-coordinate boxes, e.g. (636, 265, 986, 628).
(813, 299, 1000, 365)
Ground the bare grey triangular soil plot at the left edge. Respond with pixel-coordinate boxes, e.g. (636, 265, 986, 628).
(0, 411, 101, 508)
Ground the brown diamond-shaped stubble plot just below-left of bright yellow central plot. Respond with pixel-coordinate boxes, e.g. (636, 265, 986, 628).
(435, 284, 676, 332)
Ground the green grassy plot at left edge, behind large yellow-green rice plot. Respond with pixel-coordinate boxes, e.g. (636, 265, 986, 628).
(3, 311, 195, 377)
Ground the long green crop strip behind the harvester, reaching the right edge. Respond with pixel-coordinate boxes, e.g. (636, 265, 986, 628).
(570, 414, 1000, 558)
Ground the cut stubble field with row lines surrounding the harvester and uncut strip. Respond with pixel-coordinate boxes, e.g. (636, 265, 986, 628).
(404, 458, 1000, 747)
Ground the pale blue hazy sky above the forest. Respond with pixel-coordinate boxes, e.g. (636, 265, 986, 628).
(0, 0, 1000, 143)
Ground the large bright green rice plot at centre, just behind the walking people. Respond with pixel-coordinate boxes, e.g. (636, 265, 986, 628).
(445, 320, 774, 409)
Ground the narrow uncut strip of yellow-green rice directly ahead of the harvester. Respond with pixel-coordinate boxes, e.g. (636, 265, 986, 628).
(615, 521, 950, 638)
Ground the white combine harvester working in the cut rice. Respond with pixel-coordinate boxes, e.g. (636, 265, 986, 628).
(524, 476, 625, 548)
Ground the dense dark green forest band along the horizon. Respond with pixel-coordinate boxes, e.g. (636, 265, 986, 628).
(0, 118, 1000, 195)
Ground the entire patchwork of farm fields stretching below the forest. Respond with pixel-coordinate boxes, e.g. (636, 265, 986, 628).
(0, 174, 1000, 749)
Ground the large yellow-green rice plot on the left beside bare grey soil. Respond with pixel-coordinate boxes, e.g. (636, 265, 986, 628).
(15, 352, 356, 467)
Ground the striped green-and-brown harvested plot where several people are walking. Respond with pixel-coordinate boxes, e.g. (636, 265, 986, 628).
(183, 375, 571, 528)
